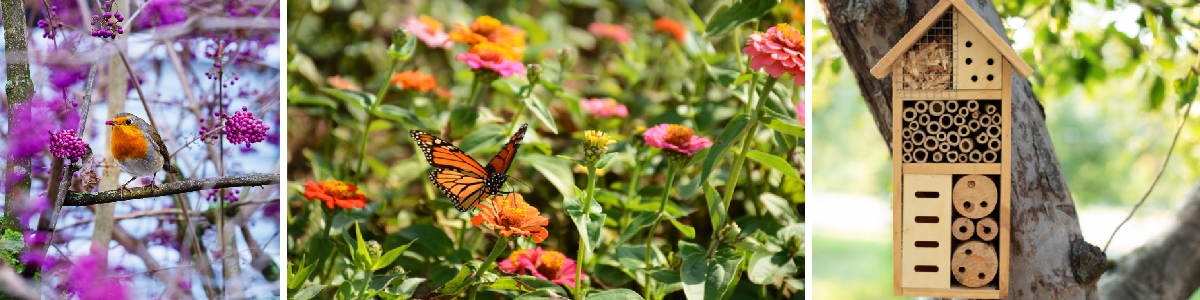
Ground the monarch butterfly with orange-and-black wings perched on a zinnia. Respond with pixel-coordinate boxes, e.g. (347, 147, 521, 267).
(409, 124, 529, 211)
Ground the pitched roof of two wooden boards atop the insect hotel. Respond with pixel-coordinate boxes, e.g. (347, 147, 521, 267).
(871, 0, 1033, 78)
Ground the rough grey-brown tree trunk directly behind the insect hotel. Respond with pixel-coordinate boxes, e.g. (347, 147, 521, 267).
(822, 0, 1104, 299)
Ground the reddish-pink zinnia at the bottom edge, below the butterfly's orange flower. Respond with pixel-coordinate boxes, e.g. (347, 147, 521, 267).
(500, 247, 588, 288)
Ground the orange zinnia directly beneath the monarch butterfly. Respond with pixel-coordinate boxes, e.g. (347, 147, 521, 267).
(470, 193, 550, 242)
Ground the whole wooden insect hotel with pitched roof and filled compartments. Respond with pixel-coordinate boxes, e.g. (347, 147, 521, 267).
(871, 0, 1033, 299)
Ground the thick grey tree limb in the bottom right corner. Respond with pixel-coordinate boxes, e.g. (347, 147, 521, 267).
(1099, 181, 1200, 299)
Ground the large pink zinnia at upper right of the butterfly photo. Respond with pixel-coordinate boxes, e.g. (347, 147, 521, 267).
(742, 23, 805, 85)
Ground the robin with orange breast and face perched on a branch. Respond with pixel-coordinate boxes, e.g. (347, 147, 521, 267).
(104, 113, 179, 190)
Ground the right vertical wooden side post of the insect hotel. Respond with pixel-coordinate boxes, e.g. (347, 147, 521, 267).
(997, 61, 1014, 298)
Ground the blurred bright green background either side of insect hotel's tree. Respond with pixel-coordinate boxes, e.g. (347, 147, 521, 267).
(808, 0, 1200, 299)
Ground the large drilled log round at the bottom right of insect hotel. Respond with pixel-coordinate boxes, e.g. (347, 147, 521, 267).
(950, 241, 1000, 288)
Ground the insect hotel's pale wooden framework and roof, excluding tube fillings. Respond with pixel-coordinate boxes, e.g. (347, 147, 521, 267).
(871, 0, 1033, 299)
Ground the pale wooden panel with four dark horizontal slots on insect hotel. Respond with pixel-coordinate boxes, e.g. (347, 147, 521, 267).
(900, 174, 954, 289)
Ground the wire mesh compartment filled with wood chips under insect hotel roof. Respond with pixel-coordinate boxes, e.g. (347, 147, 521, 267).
(893, 10, 958, 98)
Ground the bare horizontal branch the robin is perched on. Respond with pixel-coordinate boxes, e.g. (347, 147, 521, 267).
(62, 173, 280, 206)
